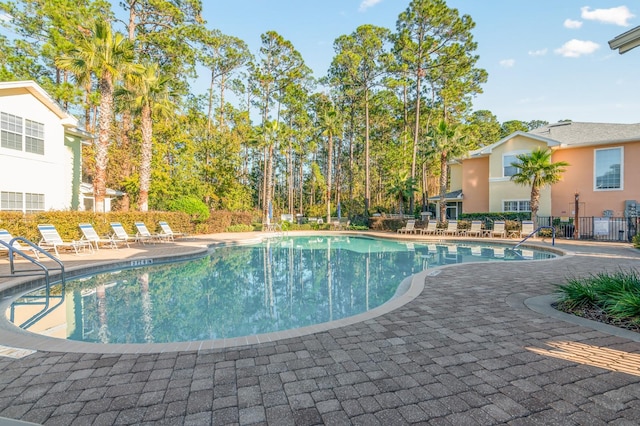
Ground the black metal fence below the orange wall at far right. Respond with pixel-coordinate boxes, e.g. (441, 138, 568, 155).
(538, 216, 640, 242)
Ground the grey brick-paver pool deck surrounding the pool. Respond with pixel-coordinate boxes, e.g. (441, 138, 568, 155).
(0, 233, 640, 426)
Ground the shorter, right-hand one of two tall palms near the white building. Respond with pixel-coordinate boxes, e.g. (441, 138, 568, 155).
(118, 64, 174, 212)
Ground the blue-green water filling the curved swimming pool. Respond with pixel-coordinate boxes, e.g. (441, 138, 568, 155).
(9, 236, 554, 343)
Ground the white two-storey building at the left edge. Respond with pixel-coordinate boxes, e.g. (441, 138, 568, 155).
(0, 81, 90, 213)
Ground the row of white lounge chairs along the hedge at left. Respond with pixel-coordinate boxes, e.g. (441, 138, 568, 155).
(0, 221, 187, 258)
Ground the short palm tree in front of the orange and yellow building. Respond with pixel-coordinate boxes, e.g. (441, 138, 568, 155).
(511, 148, 569, 229)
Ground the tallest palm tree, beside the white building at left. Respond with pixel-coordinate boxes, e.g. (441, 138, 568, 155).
(56, 20, 139, 212)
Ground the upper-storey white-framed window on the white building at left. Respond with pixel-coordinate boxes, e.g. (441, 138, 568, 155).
(0, 112, 44, 155)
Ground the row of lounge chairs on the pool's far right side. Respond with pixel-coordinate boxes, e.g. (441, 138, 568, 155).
(398, 219, 534, 238)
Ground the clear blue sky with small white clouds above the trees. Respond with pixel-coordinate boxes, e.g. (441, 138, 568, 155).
(198, 0, 640, 123)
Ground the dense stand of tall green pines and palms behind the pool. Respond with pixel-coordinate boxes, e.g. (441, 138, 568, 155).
(0, 0, 546, 217)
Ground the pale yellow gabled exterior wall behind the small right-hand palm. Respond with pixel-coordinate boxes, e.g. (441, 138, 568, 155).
(488, 135, 551, 216)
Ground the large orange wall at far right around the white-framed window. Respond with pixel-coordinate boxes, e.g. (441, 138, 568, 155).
(552, 141, 640, 217)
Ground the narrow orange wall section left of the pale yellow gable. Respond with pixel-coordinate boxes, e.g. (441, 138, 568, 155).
(460, 157, 489, 213)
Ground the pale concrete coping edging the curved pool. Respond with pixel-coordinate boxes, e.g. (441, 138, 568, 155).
(0, 232, 571, 354)
